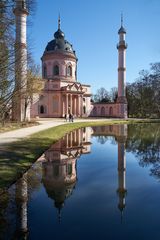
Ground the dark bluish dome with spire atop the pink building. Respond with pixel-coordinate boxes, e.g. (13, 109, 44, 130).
(45, 19, 75, 55)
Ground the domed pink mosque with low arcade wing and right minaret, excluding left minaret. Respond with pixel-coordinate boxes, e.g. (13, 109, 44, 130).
(31, 16, 127, 118)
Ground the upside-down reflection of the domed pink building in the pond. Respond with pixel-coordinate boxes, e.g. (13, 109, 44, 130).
(42, 128, 92, 220)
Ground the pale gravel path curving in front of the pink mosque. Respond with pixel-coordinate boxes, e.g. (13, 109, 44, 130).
(0, 118, 118, 145)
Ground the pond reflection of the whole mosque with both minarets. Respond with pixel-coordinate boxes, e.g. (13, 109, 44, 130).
(0, 125, 127, 239)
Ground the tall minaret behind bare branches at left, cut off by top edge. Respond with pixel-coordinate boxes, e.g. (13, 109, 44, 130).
(12, 0, 30, 121)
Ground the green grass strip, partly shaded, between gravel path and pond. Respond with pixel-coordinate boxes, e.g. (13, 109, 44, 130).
(0, 120, 160, 193)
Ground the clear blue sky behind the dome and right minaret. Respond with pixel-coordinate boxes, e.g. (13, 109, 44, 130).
(29, 0, 160, 93)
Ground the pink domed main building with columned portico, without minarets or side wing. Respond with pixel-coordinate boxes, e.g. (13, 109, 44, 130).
(31, 19, 91, 118)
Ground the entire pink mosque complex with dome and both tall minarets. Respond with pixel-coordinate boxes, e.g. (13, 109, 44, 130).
(13, 0, 127, 121)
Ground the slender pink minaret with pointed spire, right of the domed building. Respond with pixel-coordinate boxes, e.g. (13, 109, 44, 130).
(117, 15, 127, 118)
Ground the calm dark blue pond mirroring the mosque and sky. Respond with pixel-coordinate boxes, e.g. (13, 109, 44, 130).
(0, 123, 160, 240)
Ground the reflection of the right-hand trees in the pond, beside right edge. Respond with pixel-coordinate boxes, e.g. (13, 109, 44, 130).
(126, 123, 160, 178)
